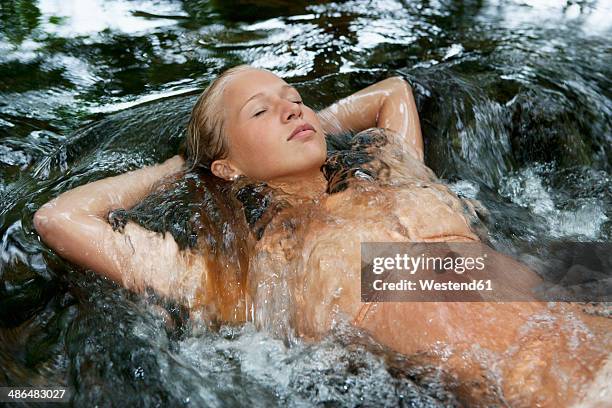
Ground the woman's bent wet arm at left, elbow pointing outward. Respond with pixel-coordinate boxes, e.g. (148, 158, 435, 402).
(34, 156, 201, 297)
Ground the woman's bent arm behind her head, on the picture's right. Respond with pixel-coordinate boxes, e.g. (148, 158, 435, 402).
(318, 76, 423, 161)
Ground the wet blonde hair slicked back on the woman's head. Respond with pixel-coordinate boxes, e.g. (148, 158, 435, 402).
(186, 65, 254, 170)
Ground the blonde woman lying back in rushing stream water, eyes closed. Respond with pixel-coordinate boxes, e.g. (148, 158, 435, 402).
(34, 66, 610, 406)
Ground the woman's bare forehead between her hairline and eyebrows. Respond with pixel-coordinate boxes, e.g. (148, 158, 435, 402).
(223, 69, 287, 104)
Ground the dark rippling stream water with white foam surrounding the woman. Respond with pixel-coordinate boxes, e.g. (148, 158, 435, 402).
(0, 0, 612, 406)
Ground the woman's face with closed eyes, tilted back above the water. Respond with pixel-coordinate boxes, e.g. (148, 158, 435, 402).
(213, 69, 327, 181)
